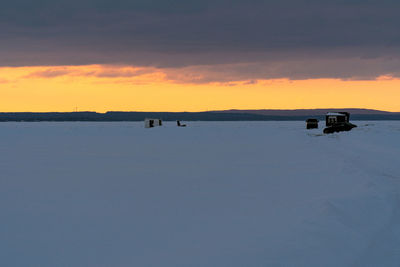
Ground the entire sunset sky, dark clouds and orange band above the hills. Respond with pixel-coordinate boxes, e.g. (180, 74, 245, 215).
(0, 0, 400, 112)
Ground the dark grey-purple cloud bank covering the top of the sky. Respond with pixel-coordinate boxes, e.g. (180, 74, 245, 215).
(0, 0, 400, 81)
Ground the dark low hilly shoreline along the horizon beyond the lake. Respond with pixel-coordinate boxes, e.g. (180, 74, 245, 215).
(0, 109, 400, 122)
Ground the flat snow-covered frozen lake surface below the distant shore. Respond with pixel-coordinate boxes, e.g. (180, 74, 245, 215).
(0, 121, 400, 267)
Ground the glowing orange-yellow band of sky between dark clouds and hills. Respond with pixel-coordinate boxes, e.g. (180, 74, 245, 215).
(0, 65, 400, 112)
